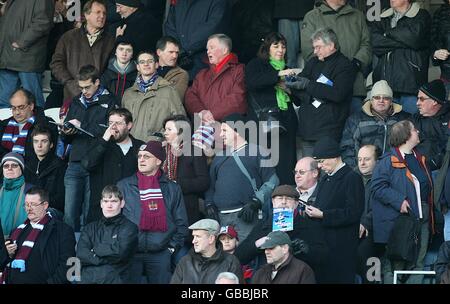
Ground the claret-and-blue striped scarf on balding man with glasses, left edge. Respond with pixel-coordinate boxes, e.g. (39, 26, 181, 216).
(2, 116, 36, 155)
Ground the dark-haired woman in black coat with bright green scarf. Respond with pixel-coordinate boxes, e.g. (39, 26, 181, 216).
(245, 33, 300, 185)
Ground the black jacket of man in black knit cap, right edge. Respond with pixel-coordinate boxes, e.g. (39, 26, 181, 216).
(413, 103, 450, 171)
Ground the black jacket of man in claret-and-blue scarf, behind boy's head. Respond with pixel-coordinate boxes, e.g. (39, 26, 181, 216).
(0, 107, 58, 163)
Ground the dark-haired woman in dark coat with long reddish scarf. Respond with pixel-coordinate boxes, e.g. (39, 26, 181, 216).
(163, 115, 209, 225)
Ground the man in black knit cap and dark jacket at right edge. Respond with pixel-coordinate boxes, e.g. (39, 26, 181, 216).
(413, 79, 450, 171)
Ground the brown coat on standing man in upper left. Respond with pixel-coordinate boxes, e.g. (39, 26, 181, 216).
(50, 26, 115, 101)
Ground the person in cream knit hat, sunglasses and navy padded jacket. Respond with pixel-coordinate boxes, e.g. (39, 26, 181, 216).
(341, 80, 410, 169)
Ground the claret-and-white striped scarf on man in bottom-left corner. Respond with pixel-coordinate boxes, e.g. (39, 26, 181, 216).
(2, 213, 51, 284)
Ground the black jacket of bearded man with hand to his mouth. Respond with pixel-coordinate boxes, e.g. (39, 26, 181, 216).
(81, 135, 144, 222)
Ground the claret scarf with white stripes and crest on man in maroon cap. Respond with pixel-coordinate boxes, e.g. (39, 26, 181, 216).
(136, 170, 167, 232)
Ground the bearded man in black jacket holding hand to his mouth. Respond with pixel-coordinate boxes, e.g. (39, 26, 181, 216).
(81, 108, 144, 223)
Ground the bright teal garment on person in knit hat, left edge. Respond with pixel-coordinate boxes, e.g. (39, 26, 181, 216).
(0, 175, 27, 235)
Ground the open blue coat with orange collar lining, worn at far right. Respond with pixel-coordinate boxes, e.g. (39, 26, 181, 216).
(371, 149, 433, 244)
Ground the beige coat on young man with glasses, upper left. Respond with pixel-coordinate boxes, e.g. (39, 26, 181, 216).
(122, 77, 186, 142)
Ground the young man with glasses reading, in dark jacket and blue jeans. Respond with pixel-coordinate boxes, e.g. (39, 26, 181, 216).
(61, 65, 117, 232)
